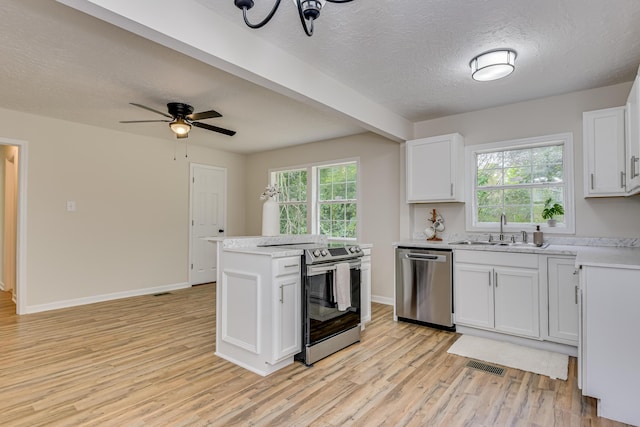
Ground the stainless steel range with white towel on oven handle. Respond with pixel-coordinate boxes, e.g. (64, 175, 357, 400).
(266, 244, 363, 365)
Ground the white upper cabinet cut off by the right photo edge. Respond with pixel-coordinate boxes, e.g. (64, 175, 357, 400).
(626, 72, 640, 195)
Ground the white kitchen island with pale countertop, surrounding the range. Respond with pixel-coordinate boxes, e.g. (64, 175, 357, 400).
(207, 235, 371, 376)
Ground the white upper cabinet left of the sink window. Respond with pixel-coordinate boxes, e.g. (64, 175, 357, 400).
(406, 133, 464, 203)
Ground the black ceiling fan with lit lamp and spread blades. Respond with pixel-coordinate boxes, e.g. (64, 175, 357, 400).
(120, 102, 236, 138)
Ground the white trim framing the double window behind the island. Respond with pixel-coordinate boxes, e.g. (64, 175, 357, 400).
(267, 157, 362, 242)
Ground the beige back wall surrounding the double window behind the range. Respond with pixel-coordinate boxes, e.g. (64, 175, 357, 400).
(246, 133, 400, 301)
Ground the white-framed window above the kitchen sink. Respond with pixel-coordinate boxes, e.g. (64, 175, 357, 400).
(467, 134, 574, 233)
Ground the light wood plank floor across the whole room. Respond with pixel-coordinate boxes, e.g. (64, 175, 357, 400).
(0, 285, 632, 426)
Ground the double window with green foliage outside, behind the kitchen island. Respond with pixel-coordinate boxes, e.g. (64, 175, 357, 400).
(271, 161, 358, 240)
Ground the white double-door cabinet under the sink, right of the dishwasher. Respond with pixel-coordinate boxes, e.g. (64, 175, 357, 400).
(454, 250, 540, 338)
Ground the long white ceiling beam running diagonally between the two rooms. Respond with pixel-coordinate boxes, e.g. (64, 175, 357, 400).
(57, 0, 414, 141)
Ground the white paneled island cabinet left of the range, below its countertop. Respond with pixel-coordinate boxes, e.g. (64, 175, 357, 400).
(216, 250, 302, 376)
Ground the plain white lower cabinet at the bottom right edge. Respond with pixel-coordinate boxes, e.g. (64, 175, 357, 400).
(579, 266, 640, 426)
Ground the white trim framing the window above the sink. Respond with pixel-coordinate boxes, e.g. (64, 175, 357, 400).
(465, 132, 576, 234)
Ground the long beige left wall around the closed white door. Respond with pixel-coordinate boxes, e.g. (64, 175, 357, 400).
(0, 110, 245, 311)
